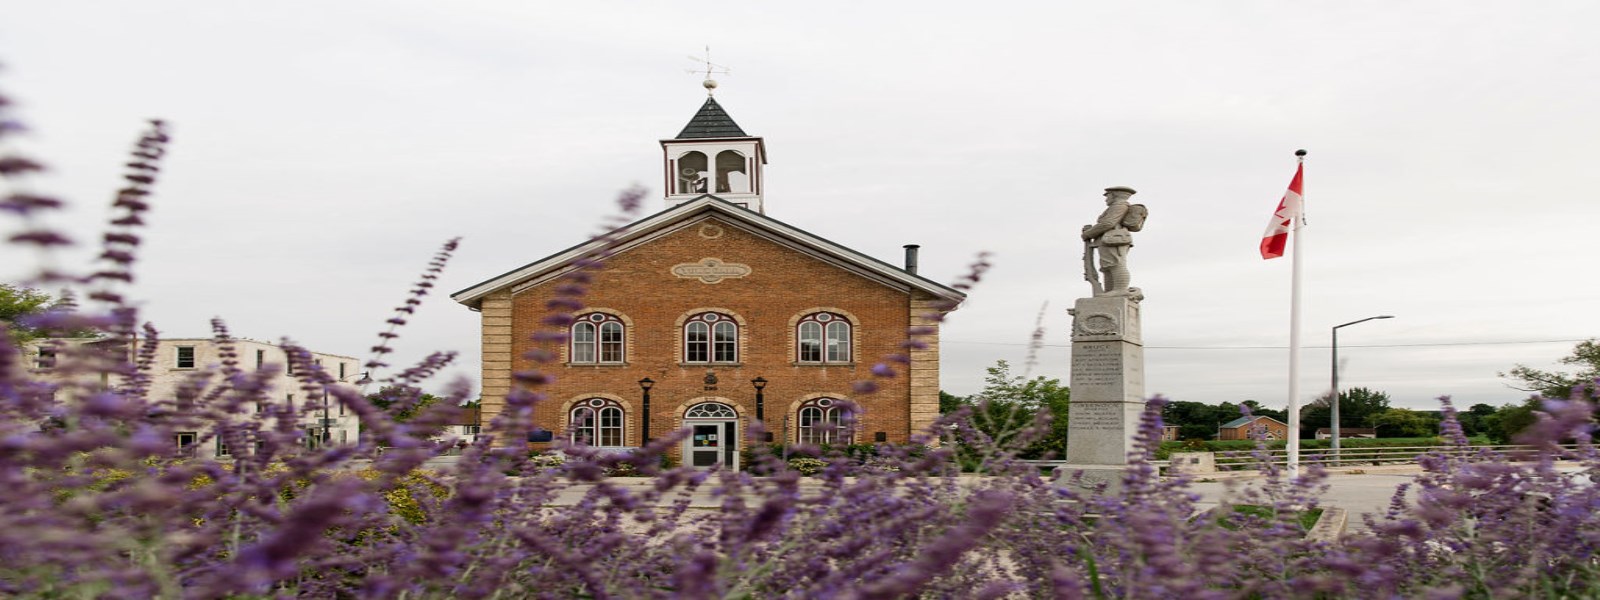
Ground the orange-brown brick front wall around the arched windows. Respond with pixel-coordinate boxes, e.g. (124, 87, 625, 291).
(482, 216, 939, 446)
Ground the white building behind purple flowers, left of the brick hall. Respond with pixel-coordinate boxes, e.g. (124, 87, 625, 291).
(24, 338, 365, 456)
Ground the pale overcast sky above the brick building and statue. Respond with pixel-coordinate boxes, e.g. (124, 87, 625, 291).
(0, 0, 1600, 408)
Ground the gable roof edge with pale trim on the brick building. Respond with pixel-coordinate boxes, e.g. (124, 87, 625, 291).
(450, 194, 966, 309)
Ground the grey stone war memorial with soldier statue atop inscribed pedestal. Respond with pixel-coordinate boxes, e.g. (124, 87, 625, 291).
(1056, 187, 1149, 488)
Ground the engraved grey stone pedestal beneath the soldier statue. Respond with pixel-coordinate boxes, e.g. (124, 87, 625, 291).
(1056, 293, 1144, 490)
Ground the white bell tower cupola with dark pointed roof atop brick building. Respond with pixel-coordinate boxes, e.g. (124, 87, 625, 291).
(661, 78, 766, 214)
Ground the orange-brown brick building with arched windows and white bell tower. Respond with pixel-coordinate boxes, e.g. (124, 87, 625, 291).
(451, 98, 963, 467)
